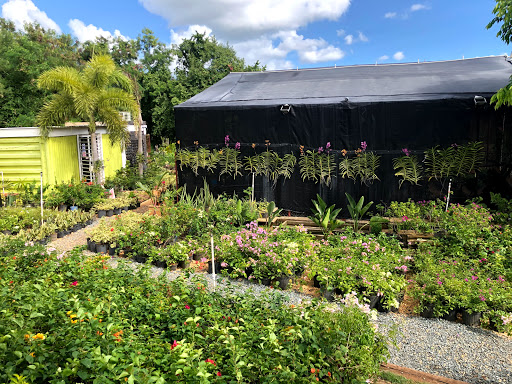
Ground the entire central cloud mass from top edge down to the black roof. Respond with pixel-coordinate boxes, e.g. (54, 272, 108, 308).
(139, 0, 352, 69)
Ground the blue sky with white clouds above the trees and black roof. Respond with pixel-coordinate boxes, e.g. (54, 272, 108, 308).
(0, 0, 512, 70)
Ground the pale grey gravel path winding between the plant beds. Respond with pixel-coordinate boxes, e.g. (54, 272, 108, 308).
(49, 224, 512, 384)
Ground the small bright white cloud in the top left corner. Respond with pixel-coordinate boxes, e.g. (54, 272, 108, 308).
(2, 0, 62, 33)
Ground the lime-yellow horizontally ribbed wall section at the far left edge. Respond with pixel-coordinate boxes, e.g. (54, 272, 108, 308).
(0, 137, 43, 184)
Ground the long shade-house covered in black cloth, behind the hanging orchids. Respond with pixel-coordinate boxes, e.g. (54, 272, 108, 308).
(175, 56, 512, 212)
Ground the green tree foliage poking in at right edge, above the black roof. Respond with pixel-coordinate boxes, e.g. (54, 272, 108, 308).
(487, 0, 512, 109)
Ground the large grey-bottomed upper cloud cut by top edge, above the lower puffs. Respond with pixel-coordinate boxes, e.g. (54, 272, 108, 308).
(139, 0, 350, 41)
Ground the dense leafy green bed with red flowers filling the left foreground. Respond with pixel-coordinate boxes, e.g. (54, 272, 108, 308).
(0, 238, 386, 383)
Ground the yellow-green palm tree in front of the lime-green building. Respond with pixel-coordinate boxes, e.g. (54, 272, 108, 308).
(37, 55, 139, 182)
